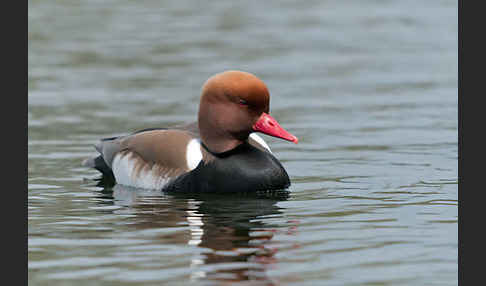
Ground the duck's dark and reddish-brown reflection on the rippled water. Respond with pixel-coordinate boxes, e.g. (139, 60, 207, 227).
(97, 185, 289, 285)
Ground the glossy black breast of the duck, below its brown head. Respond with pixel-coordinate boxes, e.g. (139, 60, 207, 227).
(164, 143, 290, 193)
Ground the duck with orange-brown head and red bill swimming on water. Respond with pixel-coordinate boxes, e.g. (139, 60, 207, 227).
(82, 70, 298, 193)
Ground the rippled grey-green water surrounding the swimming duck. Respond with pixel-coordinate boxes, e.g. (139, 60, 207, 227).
(28, 0, 458, 286)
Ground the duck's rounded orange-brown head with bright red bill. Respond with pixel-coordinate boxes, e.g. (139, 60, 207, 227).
(198, 71, 298, 153)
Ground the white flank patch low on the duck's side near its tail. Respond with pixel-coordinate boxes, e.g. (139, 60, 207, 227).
(112, 153, 169, 189)
